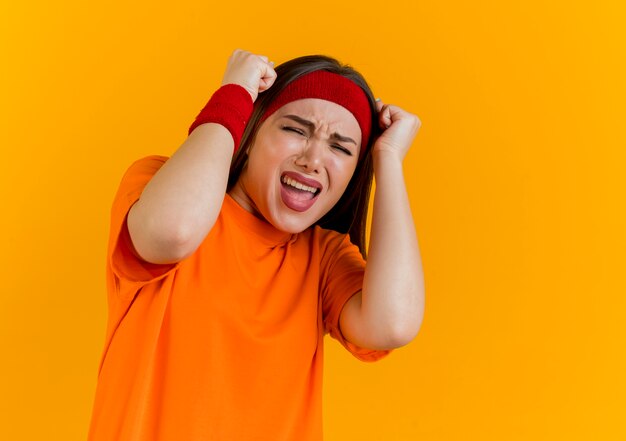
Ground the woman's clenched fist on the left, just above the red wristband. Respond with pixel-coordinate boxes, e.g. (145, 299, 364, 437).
(222, 49, 276, 102)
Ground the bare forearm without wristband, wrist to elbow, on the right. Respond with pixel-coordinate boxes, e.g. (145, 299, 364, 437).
(361, 151, 424, 340)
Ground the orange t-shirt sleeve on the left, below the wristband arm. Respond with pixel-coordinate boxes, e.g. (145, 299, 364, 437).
(107, 155, 180, 287)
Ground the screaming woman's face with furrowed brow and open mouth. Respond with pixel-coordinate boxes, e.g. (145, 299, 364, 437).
(229, 98, 361, 233)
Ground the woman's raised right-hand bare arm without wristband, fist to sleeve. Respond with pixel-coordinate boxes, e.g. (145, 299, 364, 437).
(340, 99, 424, 349)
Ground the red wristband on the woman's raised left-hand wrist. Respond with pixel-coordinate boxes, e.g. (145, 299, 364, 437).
(188, 84, 254, 152)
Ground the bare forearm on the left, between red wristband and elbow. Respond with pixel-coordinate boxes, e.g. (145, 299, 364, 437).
(137, 123, 234, 252)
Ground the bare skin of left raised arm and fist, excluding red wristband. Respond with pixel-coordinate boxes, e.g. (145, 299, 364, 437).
(128, 50, 276, 263)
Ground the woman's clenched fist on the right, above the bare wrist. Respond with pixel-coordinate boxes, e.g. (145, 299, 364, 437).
(373, 100, 422, 160)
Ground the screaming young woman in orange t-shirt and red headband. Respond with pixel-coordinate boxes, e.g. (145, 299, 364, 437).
(89, 50, 424, 441)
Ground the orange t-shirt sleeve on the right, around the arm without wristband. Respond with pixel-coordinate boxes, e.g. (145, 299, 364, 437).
(320, 232, 392, 361)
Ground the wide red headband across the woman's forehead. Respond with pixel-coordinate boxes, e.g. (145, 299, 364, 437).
(261, 70, 372, 157)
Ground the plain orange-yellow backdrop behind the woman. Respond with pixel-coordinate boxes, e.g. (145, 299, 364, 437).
(0, 0, 626, 441)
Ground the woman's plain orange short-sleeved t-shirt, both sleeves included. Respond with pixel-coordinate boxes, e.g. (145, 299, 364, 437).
(89, 155, 391, 441)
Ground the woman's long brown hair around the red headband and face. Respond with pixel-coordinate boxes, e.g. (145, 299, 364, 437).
(227, 55, 380, 258)
